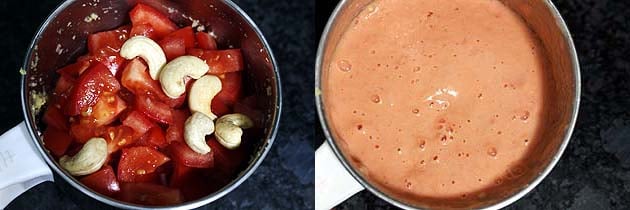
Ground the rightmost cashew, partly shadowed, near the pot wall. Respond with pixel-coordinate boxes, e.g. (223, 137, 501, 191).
(214, 113, 254, 149)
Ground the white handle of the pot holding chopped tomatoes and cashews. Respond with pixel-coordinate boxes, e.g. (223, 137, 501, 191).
(0, 122, 53, 209)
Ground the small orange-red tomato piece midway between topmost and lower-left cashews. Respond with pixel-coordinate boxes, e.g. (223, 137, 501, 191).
(91, 92, 127, 126)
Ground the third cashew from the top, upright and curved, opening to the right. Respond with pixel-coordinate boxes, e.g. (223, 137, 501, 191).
(188, 75, 221, 120)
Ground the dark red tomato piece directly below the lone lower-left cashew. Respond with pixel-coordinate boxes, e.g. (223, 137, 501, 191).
(79, 165, 120, 196)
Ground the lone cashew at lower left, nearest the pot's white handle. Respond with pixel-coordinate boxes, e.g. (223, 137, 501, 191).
(59, 137, 107, 176)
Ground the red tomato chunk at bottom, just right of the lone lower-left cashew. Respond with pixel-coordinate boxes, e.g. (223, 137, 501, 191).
(118, 146, 170, 182)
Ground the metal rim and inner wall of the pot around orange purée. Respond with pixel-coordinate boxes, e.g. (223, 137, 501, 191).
(315, 0, 580, 209)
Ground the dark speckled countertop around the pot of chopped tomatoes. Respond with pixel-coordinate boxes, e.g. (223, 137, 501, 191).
(0, 0, 315, 209)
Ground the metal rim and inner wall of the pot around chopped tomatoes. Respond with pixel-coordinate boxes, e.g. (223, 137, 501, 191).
(22, 0, 281, 209)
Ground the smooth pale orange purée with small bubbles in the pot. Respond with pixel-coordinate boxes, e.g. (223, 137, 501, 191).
(322, 0, 547, 205)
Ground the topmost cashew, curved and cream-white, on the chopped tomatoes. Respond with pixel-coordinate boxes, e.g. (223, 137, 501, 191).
(120, 36, 166, 80)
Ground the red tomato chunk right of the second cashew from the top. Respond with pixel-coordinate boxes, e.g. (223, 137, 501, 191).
(188, 49, 245, 75)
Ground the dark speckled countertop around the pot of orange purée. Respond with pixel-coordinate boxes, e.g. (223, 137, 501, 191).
(315, 0, 630, 210)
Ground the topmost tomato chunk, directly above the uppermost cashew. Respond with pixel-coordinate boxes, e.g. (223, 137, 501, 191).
(129, 4, 177, 39)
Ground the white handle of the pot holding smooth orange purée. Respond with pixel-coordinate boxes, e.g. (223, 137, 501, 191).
(315, 143, 364, 210)
